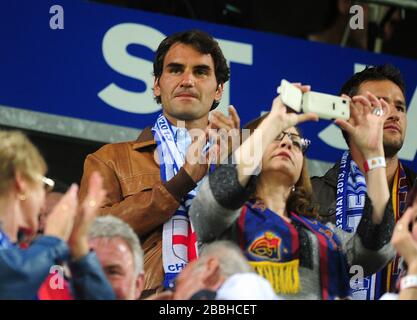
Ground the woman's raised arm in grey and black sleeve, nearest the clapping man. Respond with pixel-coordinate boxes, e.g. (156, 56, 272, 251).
(189, 87, 318, 242)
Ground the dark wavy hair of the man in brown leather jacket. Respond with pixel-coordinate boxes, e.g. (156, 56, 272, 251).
(153, 30, 230, 110)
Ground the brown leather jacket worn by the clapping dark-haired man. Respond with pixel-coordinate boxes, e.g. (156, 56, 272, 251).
(80, 128, 196, 297)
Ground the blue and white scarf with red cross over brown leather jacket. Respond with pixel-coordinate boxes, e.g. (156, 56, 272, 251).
(152, 114, 208, 288)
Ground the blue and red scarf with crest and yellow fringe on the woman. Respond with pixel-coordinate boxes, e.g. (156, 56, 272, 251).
(238, 202, 350, 300)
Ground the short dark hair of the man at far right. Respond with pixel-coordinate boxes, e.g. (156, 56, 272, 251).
(340, 64, 405, 145)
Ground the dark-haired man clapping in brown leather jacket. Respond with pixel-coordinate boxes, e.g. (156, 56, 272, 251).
(80, 30, 240, 298)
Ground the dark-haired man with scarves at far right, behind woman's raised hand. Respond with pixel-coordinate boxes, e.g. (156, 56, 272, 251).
(311, 65, 415, 300)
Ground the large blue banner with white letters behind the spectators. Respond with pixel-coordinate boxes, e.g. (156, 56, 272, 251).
(0, 0, 417, 170)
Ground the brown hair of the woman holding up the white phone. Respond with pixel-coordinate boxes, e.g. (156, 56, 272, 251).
(242, 113, 319, 219)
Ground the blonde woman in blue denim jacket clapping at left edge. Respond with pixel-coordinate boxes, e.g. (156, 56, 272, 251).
(0, 131, 114, 299)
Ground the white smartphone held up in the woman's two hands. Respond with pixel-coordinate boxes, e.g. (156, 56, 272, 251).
(278, 79, 350, 120)
